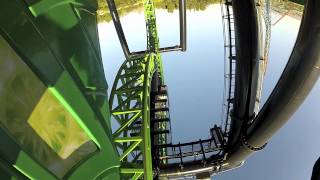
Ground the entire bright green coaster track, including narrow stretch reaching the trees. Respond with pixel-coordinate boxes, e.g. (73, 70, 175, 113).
(110, 0, 163, 179)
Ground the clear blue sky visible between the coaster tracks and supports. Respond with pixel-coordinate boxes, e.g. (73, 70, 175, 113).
(99, 4, 320, 180)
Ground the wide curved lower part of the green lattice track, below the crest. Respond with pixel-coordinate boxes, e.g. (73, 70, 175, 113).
(110, 53, 159, 179)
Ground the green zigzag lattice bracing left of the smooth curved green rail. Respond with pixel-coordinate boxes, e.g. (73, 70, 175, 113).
(110, 56, 150, 179)
